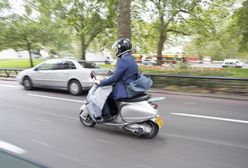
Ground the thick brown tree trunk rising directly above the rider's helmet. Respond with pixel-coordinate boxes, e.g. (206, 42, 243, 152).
(118, 0, 131, 39)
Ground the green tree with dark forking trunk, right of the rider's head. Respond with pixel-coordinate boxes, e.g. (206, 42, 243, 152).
(137, 0, 235, 65)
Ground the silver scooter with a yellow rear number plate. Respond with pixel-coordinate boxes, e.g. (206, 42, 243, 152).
(79, 73, 165, 139)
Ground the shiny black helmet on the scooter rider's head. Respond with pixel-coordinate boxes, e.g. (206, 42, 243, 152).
(112, 38, 132, 57)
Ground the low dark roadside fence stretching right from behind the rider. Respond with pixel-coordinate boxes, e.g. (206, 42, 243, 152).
(145, 74, 248, 96)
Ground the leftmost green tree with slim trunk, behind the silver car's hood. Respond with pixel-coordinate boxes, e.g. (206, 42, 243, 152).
(0, 0, 70, 67)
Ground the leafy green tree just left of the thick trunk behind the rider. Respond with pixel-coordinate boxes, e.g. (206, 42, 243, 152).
(67, 0, 115, 59)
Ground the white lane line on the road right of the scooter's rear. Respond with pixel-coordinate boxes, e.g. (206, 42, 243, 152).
(171, 113, 248, 124)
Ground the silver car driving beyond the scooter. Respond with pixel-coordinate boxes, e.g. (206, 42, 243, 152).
(17, 59, 109, 95)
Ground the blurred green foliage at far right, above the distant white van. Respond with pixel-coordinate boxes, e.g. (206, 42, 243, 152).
(185, 0, 247, 60)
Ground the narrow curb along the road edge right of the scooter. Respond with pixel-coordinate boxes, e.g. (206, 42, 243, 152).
(149, 89, 248, 101)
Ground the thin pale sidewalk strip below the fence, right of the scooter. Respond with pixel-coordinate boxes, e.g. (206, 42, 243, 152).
(149, 88, 248, 101)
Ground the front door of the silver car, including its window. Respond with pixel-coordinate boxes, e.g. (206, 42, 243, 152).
(31, 62, 54, 87)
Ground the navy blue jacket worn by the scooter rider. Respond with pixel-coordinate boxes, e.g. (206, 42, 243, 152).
(100, 53, 138, 100)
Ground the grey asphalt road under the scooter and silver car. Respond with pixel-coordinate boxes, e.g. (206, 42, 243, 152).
(0, 81, 248, 168)
